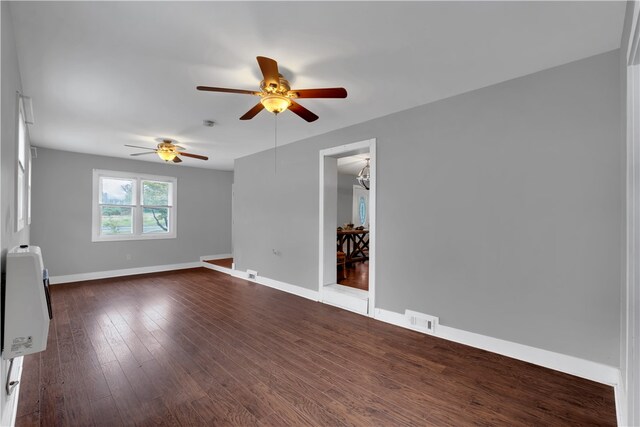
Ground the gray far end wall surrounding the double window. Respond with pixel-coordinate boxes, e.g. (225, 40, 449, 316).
(31, 148, 233, 276)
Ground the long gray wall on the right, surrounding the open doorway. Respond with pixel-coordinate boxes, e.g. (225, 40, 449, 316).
(234, 51, 624, 366)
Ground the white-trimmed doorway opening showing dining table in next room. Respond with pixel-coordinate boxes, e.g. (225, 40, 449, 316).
(319, 139, 376, 317)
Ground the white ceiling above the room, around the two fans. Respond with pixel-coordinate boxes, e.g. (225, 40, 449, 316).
(10, 1, 625, 170)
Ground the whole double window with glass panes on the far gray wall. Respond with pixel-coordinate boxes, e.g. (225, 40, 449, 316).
(92, 169, 177, 242)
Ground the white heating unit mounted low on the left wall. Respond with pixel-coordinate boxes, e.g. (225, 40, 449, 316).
(2, 245, 52, 360)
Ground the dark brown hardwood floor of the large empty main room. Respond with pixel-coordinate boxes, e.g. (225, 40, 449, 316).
(17, 269, 616, 426)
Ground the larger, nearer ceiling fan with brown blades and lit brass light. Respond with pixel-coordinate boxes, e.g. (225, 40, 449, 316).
(197, 56, 347, 122)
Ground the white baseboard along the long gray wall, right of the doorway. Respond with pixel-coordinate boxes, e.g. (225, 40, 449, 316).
(375, 308, 620, 386)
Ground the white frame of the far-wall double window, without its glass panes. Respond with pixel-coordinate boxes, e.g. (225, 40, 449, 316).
(91, 169, 178, 242)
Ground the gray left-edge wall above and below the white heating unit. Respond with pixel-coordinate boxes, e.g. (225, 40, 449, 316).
(0, 2, 29, 424)
